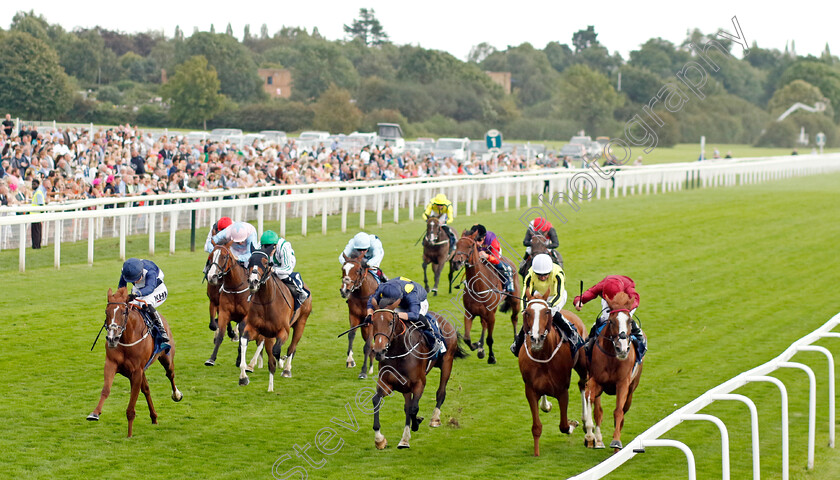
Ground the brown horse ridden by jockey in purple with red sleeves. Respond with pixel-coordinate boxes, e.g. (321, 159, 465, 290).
(452, 231, 520, 364)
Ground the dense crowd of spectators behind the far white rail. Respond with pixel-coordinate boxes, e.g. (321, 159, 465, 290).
(0, 115, 562, 205)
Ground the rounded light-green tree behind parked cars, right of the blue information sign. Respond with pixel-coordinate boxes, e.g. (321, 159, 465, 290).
(557, 65, 621, 132)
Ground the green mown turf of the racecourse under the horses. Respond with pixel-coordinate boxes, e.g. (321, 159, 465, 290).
(0, 174, 840, 479)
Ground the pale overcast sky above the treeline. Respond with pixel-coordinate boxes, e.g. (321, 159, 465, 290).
(0, 0, 840, 60)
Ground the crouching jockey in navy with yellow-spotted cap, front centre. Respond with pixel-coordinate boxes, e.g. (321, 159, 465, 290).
(365, 277, 446, 353)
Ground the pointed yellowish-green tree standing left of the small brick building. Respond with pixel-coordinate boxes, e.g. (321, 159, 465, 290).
(161, 55, 224, 129)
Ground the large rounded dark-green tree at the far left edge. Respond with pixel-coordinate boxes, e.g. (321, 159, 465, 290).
(0, 32, 73, 119)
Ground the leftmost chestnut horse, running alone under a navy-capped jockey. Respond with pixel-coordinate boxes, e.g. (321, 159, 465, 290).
(87, 287, 184, 437)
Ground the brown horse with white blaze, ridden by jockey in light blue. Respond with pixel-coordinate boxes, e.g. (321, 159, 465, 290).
(340, 256, 379, 378)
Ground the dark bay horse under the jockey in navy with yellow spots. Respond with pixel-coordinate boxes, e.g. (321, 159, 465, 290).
(371, 300, 467, 450)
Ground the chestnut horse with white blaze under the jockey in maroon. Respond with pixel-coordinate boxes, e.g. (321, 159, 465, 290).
(583, 292, 643, 452)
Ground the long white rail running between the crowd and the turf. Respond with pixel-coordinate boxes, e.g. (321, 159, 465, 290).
(0, 154, 840, 271)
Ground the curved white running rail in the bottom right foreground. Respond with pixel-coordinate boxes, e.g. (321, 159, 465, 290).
(571, 313, 840, 480)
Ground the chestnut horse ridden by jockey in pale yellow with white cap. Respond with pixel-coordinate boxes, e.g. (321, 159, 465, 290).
(519, 292, 587, 457)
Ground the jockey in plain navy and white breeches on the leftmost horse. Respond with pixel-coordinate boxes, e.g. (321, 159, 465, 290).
(117, 258, 169, 351)
